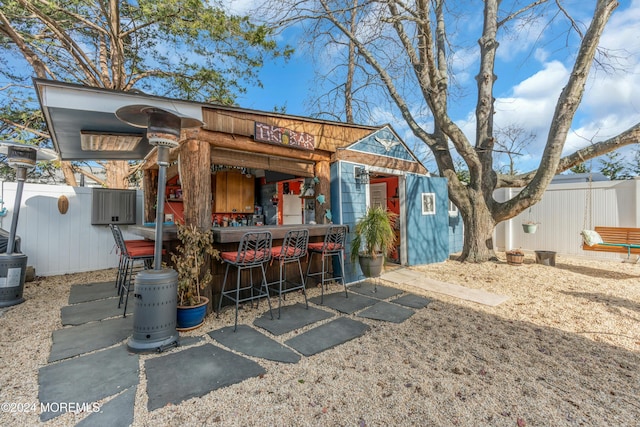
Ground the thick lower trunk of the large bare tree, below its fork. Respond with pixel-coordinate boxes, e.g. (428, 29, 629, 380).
(459, 200, 497, 262)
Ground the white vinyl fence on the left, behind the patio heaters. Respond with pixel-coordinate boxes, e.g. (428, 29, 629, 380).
(0, 181, 142, 276)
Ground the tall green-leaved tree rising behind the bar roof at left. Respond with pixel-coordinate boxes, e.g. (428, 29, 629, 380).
(0, 0, 290, 188)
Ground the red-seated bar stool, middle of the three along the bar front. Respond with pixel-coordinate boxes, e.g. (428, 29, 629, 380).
(267, 229, 309, 319)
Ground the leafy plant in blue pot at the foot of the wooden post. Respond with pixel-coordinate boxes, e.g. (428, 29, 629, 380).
(171, 223, 220, 330)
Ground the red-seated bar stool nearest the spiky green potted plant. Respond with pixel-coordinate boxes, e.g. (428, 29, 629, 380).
(305, 225, 349, 304)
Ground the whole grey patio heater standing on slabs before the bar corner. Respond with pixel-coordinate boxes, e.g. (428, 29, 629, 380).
(116, 105, 204, 353)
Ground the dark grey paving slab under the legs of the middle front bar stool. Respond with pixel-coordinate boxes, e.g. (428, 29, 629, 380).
(253, 302, 336, 335)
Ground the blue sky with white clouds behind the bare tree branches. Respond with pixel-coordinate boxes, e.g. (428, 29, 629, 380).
(231, 0, 640, 171)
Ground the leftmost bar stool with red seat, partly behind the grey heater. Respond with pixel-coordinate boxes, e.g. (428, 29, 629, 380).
(111, 224, 160, 317)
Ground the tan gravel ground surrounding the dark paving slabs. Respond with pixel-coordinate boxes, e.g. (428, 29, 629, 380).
(0, 254, 640, 427)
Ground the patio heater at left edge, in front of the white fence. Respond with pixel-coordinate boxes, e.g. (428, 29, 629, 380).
(0, 142, 58, 307)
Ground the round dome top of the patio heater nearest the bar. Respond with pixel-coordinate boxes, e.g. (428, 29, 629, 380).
(116, 104, 204, 147)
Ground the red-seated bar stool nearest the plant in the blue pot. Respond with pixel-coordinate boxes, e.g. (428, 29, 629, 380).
(216, 231, 273, 332)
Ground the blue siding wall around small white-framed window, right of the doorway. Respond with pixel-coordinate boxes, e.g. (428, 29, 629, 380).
(406, 174, 449, 265)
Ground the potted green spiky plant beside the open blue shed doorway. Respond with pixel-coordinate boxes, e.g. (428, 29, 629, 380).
(351, 206, 397, 277)
